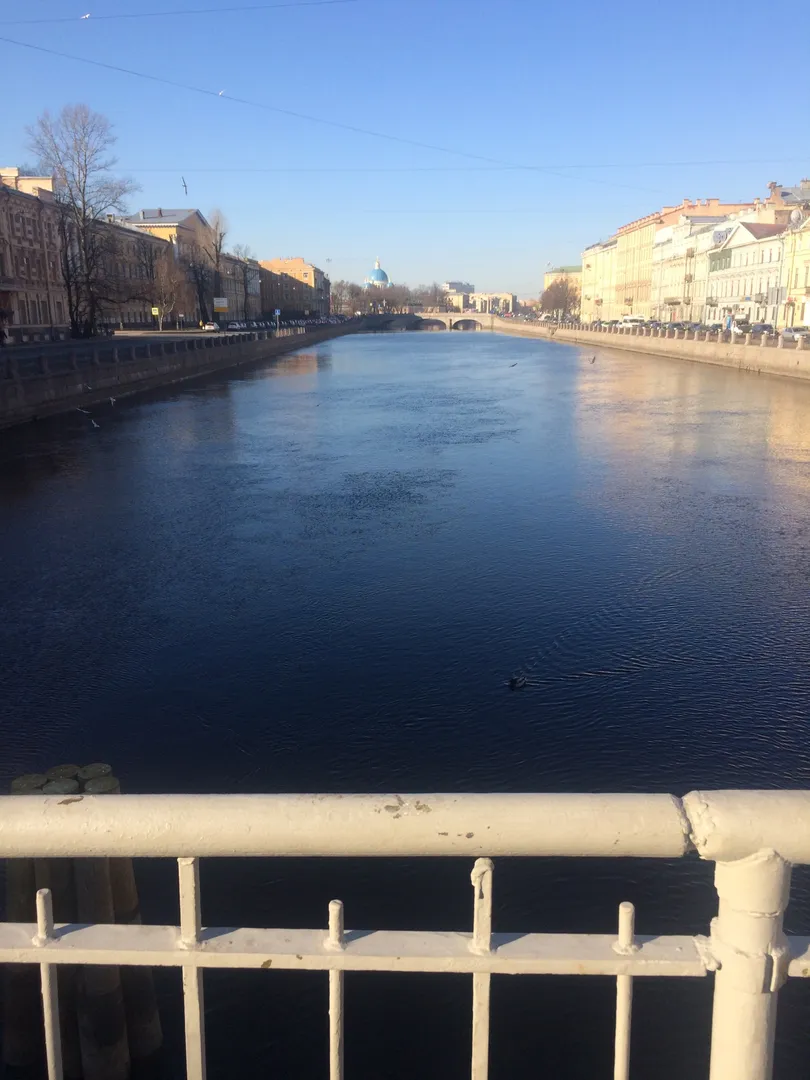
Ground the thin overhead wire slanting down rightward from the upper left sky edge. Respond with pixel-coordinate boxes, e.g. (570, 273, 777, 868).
(0, 36, 649, 191)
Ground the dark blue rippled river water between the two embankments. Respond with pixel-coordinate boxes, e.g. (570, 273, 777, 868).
(0, 333, 810, 1080)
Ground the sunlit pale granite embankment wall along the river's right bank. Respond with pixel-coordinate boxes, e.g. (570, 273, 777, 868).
(494, 319, 810, 379)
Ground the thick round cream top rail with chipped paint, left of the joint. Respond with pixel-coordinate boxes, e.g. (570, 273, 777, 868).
(0, 794, 689, 859)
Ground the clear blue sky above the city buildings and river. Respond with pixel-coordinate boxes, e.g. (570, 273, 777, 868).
(0, 0, 810, 296)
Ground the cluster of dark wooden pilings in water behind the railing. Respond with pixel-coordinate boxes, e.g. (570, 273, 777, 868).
(3, 762, 163, 1080)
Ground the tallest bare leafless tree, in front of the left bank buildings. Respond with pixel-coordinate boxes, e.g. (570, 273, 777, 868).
(28, 105, 137, 337)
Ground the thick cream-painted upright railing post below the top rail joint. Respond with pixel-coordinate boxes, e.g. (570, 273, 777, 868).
(710, 851, 791, 1080)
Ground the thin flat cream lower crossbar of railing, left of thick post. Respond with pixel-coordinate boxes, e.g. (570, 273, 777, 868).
(0, 922, 708, 976)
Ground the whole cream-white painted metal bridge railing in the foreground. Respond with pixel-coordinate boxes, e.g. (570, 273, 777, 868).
(0, 792, 810, 1080)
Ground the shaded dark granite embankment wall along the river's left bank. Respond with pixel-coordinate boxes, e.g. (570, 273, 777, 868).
(0, 326, 356, 428)
